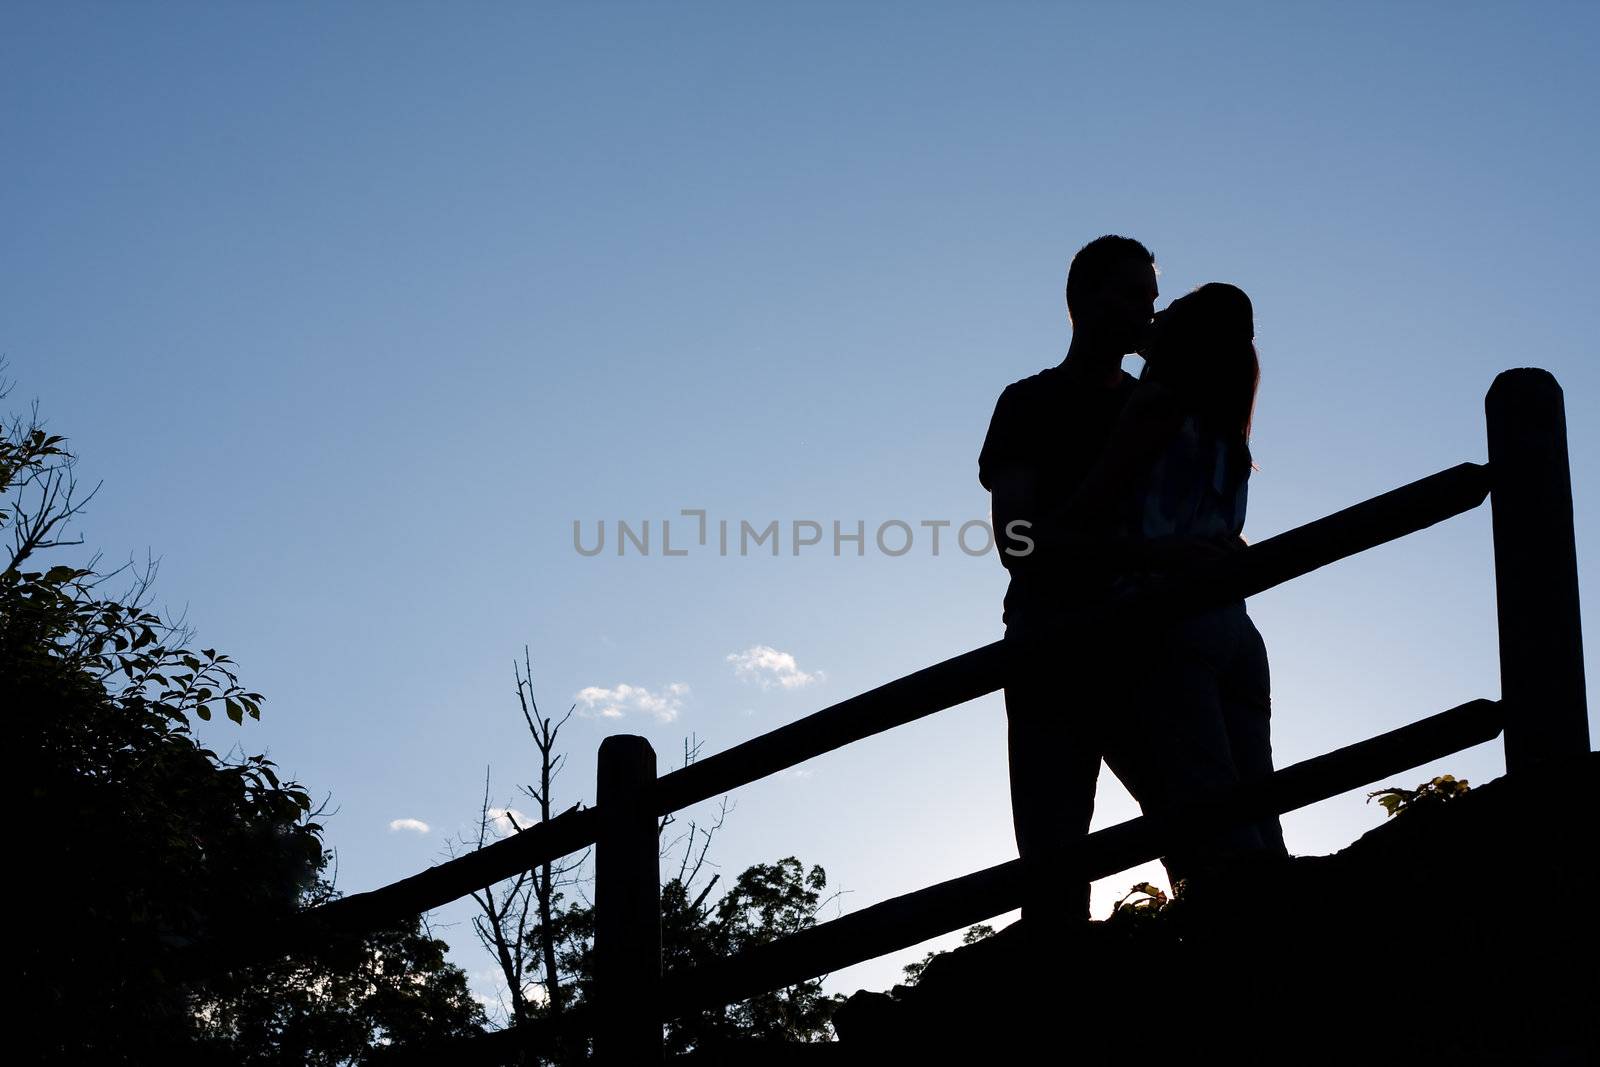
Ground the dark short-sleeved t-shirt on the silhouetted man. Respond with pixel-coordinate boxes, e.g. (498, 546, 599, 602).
(978, 366, 1138, 624)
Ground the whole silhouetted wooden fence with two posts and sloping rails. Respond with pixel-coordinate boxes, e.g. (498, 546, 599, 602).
(175, 370, 1589, 1064)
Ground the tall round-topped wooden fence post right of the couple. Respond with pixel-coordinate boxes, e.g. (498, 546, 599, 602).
(1483, 368, 1589, 771)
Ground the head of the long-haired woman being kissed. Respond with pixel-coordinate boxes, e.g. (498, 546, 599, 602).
(1146, 282, 1261, 445)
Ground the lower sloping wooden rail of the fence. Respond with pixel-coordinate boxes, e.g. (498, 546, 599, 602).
(416, 701, 1504, 1065)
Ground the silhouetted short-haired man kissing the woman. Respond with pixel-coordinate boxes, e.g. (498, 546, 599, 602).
(978, 235, 1158, 925)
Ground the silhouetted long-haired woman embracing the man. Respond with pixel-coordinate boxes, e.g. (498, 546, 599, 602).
(1070, 283, 1285, 880)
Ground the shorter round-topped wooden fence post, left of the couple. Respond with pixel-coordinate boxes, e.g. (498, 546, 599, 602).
(594, 734, 662, 1067)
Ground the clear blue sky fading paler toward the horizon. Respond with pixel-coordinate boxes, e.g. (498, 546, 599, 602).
(0, 3, 1600, 1017)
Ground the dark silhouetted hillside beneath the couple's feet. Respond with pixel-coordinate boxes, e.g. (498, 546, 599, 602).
(835, 753, 1600, 1064)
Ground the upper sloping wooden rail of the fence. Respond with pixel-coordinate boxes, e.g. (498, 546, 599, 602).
(190, 462, 1490, 974)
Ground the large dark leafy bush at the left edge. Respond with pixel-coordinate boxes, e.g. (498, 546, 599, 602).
(0, 404, 478, 1064)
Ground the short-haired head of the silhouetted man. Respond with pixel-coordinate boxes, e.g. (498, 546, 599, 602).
(1067, 234, 1160, 354)
